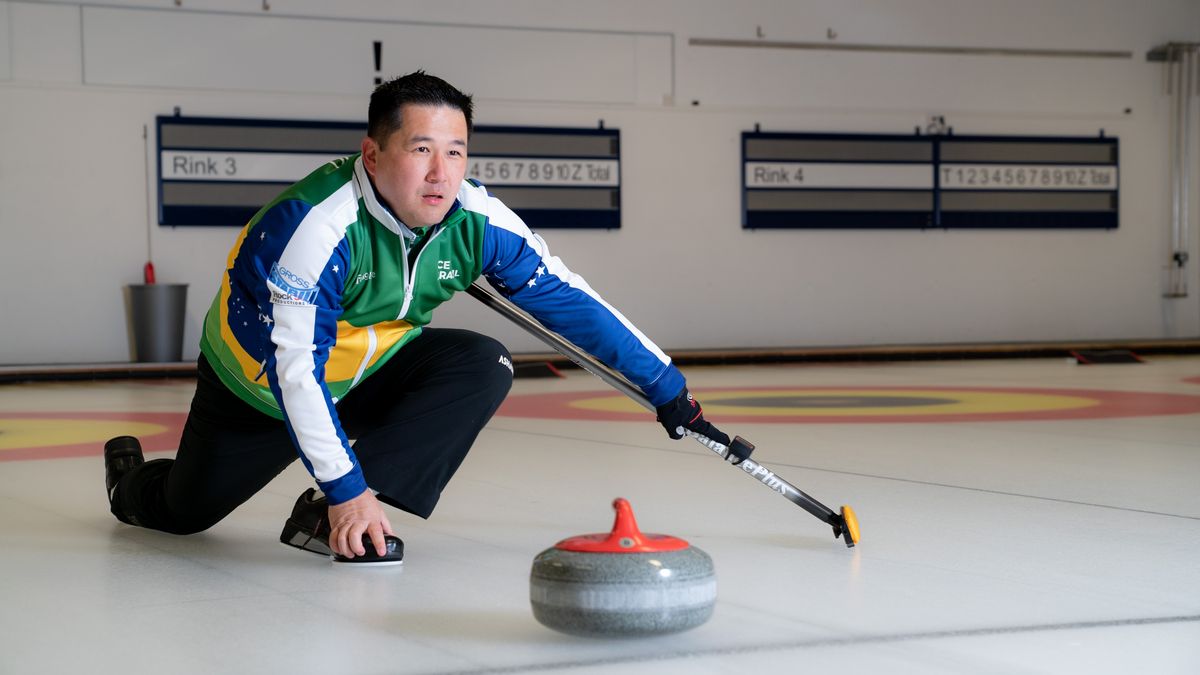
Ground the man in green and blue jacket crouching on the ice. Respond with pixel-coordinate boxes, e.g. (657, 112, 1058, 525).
(104, 71, 728, 562)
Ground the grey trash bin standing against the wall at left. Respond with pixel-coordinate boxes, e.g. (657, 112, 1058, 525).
(130, 283, 187, 363)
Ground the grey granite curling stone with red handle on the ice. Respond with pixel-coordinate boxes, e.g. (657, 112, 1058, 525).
(529, 498, 716, 638)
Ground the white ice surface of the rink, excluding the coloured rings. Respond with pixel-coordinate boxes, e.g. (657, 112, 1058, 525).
(0, 358, 1200, 674)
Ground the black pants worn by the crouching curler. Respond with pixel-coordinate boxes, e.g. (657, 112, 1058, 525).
(113, 328, 512, 534)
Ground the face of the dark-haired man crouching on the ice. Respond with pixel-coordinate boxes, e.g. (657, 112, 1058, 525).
(362, 104, 467, 227)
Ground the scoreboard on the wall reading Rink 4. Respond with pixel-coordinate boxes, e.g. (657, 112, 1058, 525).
(742, 132, 1120, 229)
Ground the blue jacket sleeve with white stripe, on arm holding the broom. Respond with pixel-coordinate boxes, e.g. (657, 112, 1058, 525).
(484, 192, 685, 406)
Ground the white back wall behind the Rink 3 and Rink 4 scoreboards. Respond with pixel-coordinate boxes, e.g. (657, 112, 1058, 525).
(0, 0, 1200, 364)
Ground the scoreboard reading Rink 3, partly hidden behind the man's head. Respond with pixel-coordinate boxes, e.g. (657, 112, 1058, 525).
(156, 117, 620, 229)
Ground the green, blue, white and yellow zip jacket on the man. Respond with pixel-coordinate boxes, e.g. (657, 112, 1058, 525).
(200, 155, 684, 504)
